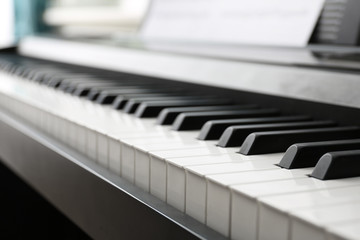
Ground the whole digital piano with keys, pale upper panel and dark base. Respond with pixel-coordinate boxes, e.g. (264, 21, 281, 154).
(0, 0, 360, 240)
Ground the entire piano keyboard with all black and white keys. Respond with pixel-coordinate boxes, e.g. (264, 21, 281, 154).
(0, 56, 360, 240)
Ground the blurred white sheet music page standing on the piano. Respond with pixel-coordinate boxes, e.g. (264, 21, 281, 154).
(142, 0, 324, 47)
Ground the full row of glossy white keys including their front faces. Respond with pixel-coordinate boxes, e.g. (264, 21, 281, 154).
(0, 70, 360, 239)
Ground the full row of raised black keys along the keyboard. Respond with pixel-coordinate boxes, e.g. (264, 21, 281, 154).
(0, 55, 360, 179)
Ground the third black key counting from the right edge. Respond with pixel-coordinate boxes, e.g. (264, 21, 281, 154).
(240, 126, 360, 155)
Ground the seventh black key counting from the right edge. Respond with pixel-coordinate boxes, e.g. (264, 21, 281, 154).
(156, 105, 255, 125)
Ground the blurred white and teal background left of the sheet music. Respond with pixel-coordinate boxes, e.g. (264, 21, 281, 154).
(0, 0, 149, 48)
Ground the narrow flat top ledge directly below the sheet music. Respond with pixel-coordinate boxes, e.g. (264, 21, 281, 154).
(39, 35, 360, 72)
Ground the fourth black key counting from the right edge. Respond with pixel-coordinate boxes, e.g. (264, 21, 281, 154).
(217, 121, 336, 147)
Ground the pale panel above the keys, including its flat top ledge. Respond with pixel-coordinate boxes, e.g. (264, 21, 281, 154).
(18, 36, 360, 111)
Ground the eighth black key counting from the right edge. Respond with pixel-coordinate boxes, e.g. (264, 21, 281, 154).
(135, 98, 231, 118)
